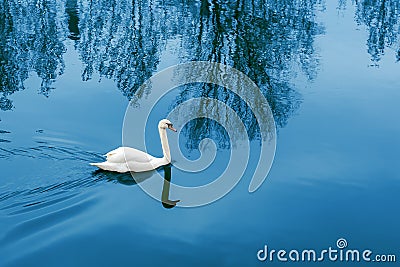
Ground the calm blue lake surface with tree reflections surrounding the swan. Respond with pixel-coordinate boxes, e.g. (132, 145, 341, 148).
(0, 0, 400, 266)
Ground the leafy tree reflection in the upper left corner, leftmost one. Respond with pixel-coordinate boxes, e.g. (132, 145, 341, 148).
(0, 0, 65, 110)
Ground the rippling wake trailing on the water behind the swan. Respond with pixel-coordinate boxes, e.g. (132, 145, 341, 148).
(0, 142, 136, 216)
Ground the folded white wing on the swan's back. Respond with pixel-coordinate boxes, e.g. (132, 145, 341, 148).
(106, 147, 154, 163)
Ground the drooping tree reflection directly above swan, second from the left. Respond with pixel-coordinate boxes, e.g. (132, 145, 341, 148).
(78, 0, 165, 99)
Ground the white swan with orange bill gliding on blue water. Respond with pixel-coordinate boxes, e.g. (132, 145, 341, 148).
(90, 119, 176, 173)
